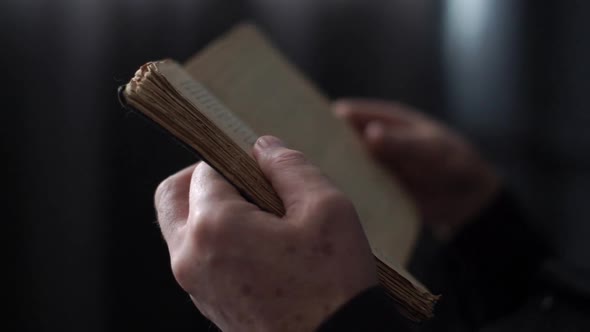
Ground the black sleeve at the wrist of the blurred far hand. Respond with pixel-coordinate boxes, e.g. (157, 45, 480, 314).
(419, 191, 547, 331)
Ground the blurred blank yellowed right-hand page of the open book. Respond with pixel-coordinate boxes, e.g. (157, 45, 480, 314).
(185, 25, 419, 268)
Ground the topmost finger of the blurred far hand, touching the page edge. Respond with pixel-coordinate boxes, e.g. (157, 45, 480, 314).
(333, 99, 419, 133)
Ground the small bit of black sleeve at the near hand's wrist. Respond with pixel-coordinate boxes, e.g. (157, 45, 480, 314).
(317, 286, 413, 332)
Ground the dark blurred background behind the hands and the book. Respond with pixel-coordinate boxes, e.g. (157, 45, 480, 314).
(0, 0, 590, 331)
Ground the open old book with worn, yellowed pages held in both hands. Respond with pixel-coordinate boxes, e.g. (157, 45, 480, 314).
(120, 24, 437, 321)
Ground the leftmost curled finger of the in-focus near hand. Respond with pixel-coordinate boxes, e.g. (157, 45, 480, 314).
(154, 165, 196, 241)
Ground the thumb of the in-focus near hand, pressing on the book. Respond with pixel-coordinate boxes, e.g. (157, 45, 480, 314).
(253, 136, 331, 214)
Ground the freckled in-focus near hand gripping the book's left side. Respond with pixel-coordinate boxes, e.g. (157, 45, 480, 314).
(155, 136, 377, 331)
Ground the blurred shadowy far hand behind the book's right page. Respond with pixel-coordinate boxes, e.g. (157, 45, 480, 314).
(334, 100, 500, 226)
